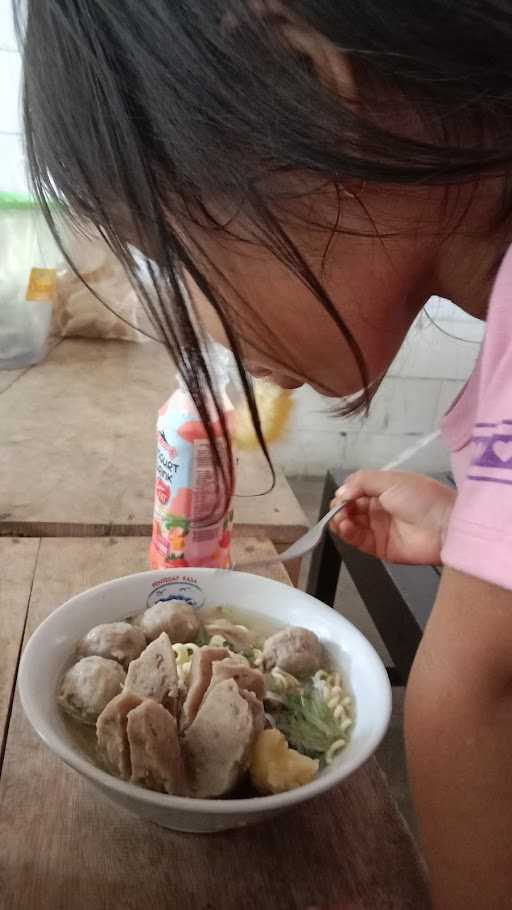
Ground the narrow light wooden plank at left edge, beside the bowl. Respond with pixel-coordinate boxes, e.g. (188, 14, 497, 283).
(0, 538, 39, 766)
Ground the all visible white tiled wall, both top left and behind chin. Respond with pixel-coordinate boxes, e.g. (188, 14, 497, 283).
(0, 0, 482, 474)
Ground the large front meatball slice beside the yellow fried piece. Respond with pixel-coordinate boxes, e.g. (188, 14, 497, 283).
(183, 679, 258, 798)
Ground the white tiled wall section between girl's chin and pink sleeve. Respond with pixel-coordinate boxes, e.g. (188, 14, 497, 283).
(273, 298, 484, 475)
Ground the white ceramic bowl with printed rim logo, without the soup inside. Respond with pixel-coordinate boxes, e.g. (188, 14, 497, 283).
(19, 569, 391, 832)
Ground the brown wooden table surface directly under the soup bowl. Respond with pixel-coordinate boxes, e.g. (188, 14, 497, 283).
(0, 536, 428, 910)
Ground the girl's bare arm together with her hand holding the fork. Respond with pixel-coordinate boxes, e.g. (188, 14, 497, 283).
(333, 471, 512, 910)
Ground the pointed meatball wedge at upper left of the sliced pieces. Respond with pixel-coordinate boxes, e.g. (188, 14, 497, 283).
(125, 632, 178, 714)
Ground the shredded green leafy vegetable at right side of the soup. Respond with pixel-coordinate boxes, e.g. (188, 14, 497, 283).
(275, 683, 342, 758)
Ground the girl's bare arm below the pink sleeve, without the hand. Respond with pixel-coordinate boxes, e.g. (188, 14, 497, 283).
(406, 568, 512, 910)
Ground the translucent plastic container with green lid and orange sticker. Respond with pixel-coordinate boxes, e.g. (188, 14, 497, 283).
(0, 193, 58, 369)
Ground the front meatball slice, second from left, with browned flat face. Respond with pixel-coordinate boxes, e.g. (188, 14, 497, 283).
(127, 698, 186, 795)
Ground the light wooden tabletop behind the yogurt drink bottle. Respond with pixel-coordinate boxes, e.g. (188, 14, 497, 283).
(0, 339, 307, 544)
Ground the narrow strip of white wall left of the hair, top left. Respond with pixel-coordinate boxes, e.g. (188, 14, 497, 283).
(0, 0, 27, 193)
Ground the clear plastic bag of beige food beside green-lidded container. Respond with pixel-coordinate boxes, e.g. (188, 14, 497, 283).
(54, 228, 154, 341)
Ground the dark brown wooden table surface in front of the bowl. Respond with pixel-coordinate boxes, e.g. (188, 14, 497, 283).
(0, 716, 428, 910)
